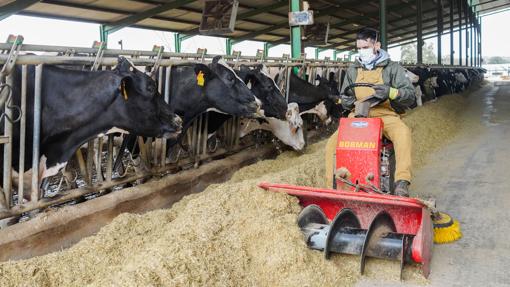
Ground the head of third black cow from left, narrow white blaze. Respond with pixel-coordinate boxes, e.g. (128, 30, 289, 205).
(239, 65, 287, 120)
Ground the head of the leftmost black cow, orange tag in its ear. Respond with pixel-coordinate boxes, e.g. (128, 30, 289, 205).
(113, 57, 182, 138)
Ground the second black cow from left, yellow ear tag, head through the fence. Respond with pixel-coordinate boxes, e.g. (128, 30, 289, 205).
(114, 56, 263, 170)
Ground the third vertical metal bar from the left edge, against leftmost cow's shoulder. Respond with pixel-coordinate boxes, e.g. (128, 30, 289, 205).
(31, 64, 43, 202)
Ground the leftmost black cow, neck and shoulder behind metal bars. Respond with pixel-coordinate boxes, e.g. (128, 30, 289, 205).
(0, 57, 182, 212)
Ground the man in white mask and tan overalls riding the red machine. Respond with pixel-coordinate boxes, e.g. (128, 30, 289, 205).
(326, 28, 415, 196)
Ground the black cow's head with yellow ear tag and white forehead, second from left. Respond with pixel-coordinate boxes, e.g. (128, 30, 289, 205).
(195, 56, 261, 117)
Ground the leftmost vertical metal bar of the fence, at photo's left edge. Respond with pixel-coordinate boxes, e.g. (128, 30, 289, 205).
(3, 74, 14, 208)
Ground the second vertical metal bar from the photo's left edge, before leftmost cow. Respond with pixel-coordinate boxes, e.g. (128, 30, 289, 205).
(18, 65, 28, 204)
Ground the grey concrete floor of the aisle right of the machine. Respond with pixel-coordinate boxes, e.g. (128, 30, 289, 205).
(358, 82, 510, 286)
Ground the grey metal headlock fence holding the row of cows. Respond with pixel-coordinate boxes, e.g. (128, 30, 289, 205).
(0, 36, 484, 225)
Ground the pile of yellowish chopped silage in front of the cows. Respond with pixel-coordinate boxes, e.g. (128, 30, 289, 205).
(0, 96, 464, 286)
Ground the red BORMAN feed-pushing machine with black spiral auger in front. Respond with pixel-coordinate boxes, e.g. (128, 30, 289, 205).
(259, 86, 434, 277)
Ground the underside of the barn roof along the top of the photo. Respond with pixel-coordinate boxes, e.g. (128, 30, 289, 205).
(0, 0, 510, 50)
